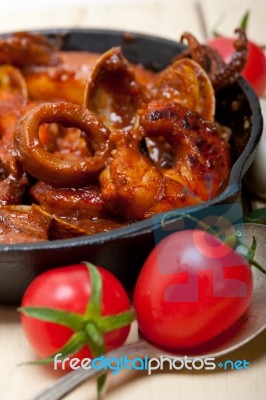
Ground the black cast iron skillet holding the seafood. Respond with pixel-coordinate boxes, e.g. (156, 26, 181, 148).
(0, 29, 262, 304)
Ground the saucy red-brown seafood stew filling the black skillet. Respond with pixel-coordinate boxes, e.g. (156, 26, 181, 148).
(0, 30, 255, 244)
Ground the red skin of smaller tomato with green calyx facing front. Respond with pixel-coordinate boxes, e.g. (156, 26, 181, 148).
(21, 264, 133, 366)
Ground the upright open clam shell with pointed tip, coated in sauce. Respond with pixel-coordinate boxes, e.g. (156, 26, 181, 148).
(84, 47, 144, 130)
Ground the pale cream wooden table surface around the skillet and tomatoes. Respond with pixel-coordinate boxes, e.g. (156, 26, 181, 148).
(0, 0, 266, 400)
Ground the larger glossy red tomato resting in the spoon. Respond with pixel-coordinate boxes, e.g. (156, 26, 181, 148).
(134, 230, 253, 350)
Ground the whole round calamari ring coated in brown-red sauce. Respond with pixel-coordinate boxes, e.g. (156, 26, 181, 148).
(14, 102, 112, 187)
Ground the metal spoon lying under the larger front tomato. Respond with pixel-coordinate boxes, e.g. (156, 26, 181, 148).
(29, 224, 266, 400)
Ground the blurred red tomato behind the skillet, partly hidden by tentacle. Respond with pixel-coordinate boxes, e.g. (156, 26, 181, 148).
(207, 36, 266, 97)
